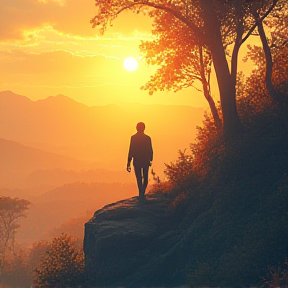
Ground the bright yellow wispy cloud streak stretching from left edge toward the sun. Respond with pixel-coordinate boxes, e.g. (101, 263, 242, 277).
(0, 26, 152, 59)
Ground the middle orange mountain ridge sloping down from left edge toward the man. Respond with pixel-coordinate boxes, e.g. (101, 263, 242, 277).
(0, 138, 132, 189)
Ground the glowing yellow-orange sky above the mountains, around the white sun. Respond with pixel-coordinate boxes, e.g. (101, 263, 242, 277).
(0, 0, 256, 107)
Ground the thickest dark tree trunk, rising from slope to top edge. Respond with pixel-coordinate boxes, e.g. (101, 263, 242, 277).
(201, 0, 241, 137)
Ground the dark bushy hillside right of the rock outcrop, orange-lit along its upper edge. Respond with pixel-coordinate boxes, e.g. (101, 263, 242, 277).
(155, 53, 288, 286)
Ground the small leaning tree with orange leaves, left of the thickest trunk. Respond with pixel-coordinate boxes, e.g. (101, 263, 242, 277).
(140, 13, 222, 129)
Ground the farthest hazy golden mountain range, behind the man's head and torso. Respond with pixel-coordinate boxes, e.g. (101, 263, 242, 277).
(0, 91, 204, 173)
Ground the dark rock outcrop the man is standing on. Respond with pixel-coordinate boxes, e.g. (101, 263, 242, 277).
(84, 194, 182, 287)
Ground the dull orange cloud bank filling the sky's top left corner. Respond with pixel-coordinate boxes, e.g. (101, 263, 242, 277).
(0, 0, 96, 40)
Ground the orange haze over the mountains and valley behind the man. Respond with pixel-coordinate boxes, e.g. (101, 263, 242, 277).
(0, 91, 203, 244)
